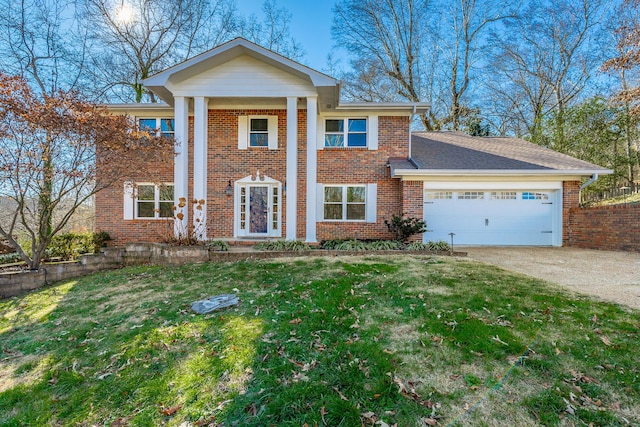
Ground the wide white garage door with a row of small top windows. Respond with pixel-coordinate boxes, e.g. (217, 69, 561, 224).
(424, 190, 559, 246)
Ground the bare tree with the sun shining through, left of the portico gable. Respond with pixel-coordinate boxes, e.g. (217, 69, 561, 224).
(85, 0, 236, 102)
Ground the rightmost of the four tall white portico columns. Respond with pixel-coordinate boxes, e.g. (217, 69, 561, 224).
(306, 96, 318, 243)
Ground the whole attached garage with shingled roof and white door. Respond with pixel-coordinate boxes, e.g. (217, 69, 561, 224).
(389, 132, 612, 246)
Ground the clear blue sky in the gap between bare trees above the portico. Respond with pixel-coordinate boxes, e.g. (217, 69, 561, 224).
(236, 0, 345, 70)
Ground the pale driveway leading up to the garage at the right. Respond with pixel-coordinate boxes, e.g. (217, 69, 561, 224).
(456, 246, 640, 310)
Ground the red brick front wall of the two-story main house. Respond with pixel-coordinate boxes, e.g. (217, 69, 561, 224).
(96, 109, 412, 245)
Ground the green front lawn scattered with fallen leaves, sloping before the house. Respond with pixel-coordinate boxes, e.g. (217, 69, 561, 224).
(0, 255, 640, 426)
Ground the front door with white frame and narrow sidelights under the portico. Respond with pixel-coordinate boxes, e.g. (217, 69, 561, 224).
(236, 177, 281, 237)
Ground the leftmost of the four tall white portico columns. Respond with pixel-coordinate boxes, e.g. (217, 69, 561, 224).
(173, 96, 189, 238)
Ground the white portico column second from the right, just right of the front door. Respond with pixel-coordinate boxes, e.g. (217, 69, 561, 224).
(286, 96, 298, 240)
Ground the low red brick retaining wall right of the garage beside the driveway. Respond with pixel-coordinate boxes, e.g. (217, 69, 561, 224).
(567, 204, 640, 252)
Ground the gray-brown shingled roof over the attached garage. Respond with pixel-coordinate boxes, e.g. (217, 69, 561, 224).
(404, 132, 610, 173)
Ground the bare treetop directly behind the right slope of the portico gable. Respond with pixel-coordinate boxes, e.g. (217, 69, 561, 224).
(238, 0, 305, 61)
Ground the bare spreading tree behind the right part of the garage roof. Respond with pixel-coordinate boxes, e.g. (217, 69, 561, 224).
(493, 0, 605, 146)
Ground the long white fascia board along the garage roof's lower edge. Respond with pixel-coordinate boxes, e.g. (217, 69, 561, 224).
(391, 169, 613, 181)
